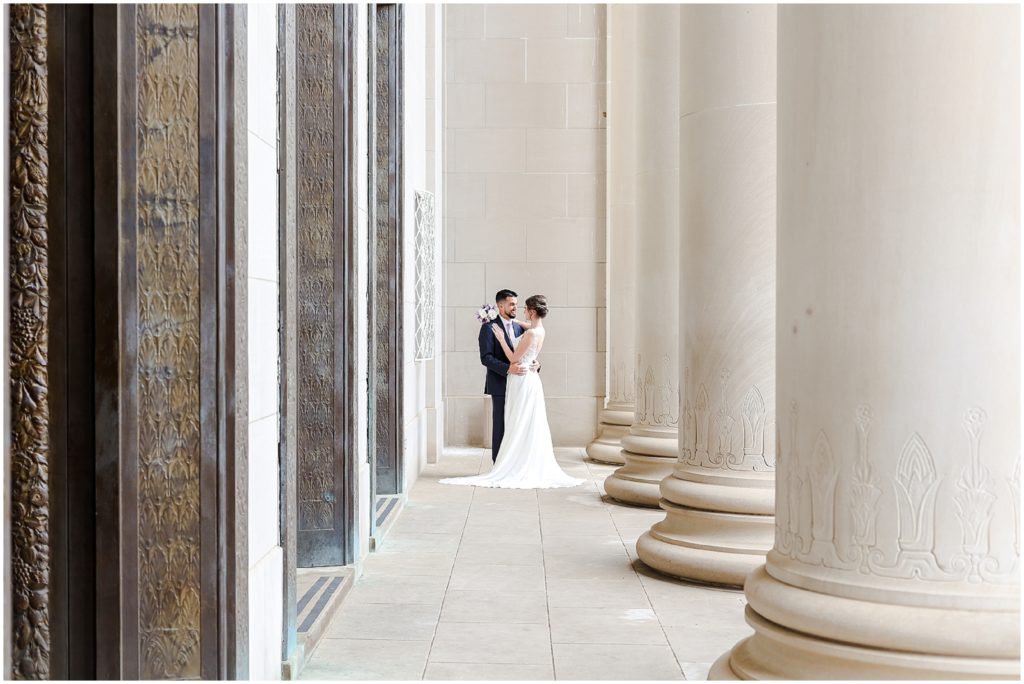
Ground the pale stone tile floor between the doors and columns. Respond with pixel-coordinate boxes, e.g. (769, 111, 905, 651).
(301, 448, 751, 680)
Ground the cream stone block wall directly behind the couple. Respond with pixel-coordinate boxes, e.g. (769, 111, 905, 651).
(442, 4, 606, 446)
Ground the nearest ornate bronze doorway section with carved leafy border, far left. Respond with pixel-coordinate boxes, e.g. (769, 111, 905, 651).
(10, 4, 248, 679)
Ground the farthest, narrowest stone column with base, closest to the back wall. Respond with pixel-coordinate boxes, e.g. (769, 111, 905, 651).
(587, 4, 637, 465)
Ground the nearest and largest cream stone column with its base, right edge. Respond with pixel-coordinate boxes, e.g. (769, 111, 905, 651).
(712, 5, 1021, 679)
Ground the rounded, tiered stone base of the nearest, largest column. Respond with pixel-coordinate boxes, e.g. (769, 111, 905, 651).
(709, 566, 1020, 680)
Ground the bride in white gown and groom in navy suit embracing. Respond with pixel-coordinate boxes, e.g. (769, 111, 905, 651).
(440, 290, 583, 489)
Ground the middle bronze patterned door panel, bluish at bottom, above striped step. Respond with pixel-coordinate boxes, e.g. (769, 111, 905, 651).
(283, 4, 357, 567)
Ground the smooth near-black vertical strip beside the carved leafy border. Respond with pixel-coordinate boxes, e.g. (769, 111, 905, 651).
(47, 4, 96, 679)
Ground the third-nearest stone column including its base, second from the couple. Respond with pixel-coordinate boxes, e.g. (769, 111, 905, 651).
(604, 5, 679, 507)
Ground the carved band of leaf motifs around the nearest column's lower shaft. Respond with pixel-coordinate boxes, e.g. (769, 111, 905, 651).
(775, 404, 1020, 584)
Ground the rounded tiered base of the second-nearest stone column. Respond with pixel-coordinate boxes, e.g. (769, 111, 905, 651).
(637, 499, 775, 588)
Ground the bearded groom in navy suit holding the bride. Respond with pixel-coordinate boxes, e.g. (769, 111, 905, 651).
(477, 290, 541, 461)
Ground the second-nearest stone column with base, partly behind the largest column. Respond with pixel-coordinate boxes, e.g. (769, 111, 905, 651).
(637, 5, 776, 585)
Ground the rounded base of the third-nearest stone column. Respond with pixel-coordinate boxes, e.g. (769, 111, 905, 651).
(604, 428, 679, 508)
